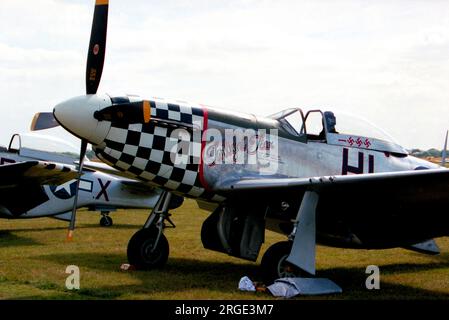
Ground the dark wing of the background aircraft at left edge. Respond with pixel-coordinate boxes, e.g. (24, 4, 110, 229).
(0, 161, 77, 188)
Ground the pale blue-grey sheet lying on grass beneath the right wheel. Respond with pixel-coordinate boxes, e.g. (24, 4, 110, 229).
(267, 278, 343, 298)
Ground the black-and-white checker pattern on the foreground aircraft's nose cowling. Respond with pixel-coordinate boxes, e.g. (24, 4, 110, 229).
(98, 101, 205, 197)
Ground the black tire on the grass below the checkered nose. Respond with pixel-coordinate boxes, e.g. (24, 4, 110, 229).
(127, 227, 169, 270)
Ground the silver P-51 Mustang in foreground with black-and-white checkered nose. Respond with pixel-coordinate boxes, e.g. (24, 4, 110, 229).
(34, 0, 449, 284)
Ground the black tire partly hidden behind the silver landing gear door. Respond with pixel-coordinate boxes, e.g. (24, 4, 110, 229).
(260, 241, 303, 284)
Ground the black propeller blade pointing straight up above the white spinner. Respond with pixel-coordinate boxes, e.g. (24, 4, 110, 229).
(86, 0, 109, 94)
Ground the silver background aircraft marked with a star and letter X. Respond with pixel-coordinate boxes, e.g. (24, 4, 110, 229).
(0, 134, 182, 226)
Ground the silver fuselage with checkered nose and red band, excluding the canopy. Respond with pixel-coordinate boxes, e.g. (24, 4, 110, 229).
(55, 97, 439, 202)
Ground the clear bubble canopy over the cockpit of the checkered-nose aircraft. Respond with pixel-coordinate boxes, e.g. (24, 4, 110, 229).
(270, 108, 408, 155)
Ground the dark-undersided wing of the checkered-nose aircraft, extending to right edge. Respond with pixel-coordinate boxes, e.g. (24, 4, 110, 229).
(214, 168, 449, 248)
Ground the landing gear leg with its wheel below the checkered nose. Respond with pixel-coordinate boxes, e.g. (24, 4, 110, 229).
(127, 191, 175, 270)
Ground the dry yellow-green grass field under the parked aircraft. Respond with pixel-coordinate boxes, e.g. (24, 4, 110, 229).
(0, 200, 449, 299)
